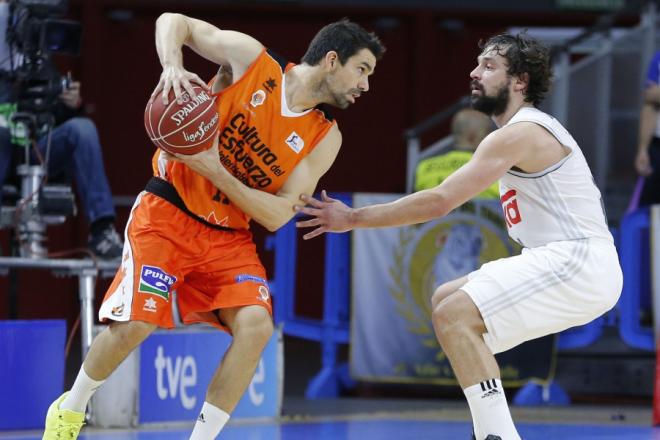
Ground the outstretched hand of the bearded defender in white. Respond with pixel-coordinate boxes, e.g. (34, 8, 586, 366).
(294, 190, 354, 240)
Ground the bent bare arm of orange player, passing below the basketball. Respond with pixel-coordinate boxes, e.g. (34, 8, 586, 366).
(170, 125, 341, 232)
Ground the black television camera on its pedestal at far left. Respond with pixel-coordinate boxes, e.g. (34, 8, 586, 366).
(0, 0, 82, 258)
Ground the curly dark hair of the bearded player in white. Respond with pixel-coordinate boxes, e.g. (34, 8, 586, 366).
(479, 32, 552, 107)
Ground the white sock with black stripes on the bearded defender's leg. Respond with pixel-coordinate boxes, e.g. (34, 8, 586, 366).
(463, 379, 520, 440)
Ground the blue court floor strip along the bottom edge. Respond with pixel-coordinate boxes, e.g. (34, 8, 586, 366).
(0, 419, 660, 440)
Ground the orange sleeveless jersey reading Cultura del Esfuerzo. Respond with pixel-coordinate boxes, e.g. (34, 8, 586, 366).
(152, 49, 334, 229)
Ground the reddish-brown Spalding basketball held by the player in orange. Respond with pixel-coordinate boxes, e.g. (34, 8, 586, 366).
(144, 85, 218, 154)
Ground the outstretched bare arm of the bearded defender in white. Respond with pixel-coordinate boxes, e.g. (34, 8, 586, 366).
(296, 123, 566, 240)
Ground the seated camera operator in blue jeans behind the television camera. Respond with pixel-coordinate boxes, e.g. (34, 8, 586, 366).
(0, 0, 123, 259)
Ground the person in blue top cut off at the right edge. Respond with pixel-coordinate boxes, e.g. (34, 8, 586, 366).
(635, 51, 660, 206)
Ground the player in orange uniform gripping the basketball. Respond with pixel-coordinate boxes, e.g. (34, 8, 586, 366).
(44, 13, 385, 440)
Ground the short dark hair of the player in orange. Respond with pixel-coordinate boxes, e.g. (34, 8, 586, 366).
(301, 18, 385, 66)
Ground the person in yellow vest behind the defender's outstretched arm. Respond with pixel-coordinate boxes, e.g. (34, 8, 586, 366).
(415, 108, 500, 199)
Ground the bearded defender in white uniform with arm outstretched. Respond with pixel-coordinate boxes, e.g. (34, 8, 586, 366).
(297, 34, 623, 440)
